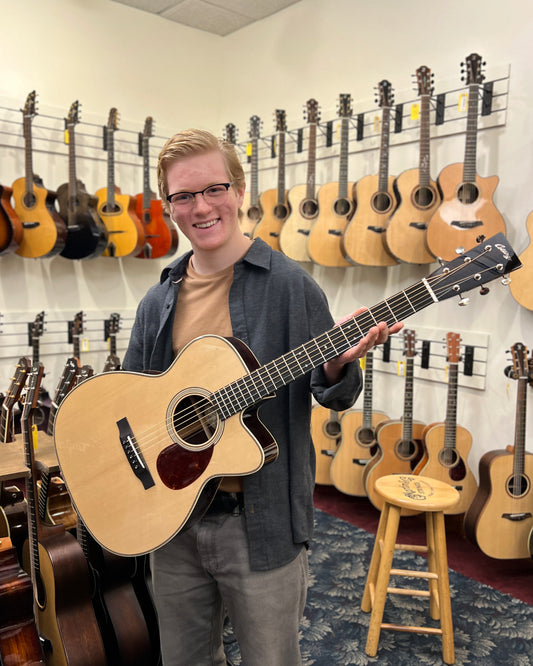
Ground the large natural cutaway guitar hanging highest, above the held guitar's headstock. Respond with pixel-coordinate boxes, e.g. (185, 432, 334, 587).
(427, 53, 505, 261)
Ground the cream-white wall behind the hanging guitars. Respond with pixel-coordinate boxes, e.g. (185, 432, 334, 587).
(0, 0, 533, 478)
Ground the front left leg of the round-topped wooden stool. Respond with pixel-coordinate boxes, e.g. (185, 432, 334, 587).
(366, 503, 402, 657)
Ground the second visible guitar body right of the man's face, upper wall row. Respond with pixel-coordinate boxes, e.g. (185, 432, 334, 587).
(254, 109, 291, 251)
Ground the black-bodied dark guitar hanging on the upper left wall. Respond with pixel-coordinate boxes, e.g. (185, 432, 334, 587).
(57, 100, 108, 259)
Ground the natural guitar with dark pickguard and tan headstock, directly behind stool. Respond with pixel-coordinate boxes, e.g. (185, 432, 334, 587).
(414, 332, 478, 515)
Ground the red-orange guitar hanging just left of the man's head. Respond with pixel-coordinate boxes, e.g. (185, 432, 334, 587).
(135, 116, 179, 259)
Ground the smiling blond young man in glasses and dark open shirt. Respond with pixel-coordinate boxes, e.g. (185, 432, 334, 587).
(124, 130, 401, 666)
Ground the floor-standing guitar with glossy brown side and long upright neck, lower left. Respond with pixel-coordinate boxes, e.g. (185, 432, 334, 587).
(22, 363, 107, 666)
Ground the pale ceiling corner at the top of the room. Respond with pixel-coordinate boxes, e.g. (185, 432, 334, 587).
(112, 0, 300, 37)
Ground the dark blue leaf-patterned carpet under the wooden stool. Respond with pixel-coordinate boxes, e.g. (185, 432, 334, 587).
(227, 510, 533, 666)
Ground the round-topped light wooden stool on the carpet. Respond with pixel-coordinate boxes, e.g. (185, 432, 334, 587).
(361, 474, 459, 664)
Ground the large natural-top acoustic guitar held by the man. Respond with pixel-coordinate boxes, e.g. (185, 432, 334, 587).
(55, 234, 520, 555)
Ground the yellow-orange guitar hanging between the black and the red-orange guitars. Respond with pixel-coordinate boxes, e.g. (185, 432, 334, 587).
(95, 107, 145, 257)
